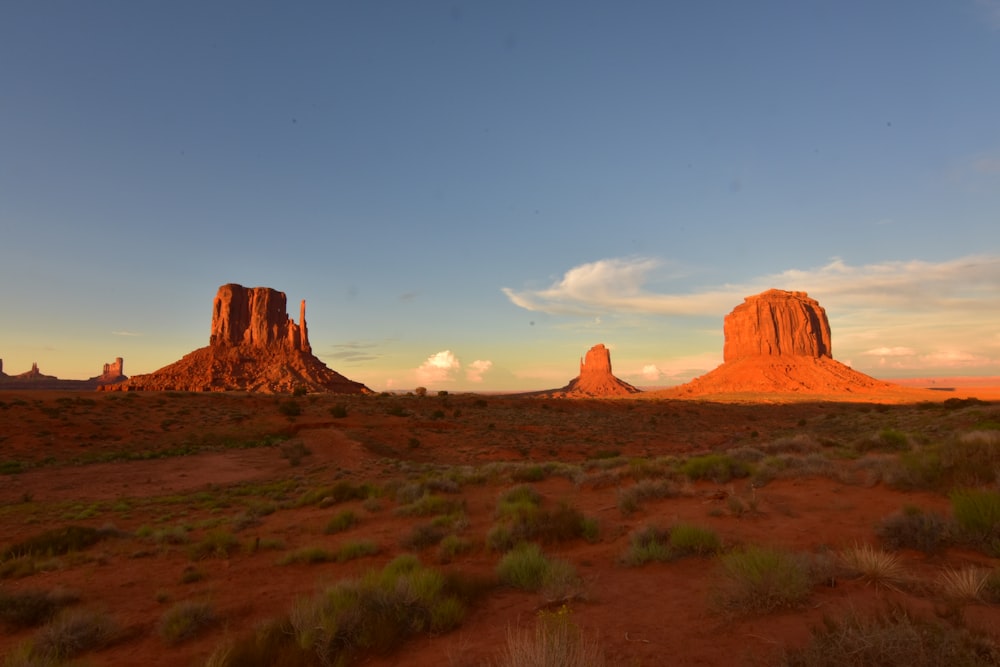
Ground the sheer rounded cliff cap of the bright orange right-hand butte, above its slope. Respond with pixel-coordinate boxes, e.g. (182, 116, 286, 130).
(722, 289, 833, 361)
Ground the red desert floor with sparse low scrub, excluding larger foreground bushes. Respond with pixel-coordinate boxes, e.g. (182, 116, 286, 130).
(0, 387, 1000, 665)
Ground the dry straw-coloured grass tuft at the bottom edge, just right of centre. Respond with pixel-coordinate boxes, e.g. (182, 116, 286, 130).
(495, 605, 609, 667)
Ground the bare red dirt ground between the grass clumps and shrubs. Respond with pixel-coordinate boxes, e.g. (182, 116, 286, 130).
(0, 387, 1000, 667)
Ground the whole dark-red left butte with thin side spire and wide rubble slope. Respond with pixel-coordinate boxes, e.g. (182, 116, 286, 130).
(104, 283, 371, 394)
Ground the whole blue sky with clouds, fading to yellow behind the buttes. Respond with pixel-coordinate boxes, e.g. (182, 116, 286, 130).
(0, 0, 1000, 391)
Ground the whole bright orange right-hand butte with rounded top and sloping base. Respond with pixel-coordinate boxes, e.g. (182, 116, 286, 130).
(664, 289, 894, 396)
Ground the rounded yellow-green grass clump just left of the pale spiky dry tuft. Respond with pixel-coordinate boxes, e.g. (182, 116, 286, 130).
(713, 545, 810, 613)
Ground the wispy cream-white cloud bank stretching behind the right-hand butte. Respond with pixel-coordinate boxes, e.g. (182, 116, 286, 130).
(504, 254, 1000, 377)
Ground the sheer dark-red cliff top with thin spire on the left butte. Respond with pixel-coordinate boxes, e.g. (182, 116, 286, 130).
(209, 283, 312, 352)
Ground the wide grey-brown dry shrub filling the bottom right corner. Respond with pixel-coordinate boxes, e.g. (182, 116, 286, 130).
(778, 607, 1000, 667)
